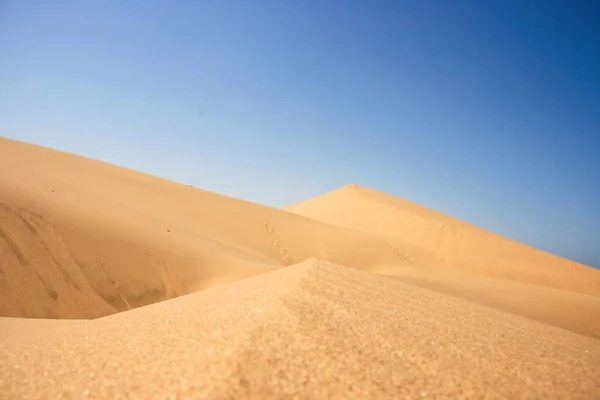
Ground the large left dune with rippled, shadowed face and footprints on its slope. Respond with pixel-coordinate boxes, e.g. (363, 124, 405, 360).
(0, 139, 400, 318)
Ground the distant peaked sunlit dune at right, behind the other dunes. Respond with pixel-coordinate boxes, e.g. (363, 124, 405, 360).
(284, 185, 600, 296)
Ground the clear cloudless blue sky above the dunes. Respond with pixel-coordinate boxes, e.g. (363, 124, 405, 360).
(0, 0, 600, 266)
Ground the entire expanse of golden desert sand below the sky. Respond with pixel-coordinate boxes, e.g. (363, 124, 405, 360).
(0, 138, 600, 399)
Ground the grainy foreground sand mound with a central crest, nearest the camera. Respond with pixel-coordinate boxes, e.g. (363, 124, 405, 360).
(0, 260, 600, 399)
